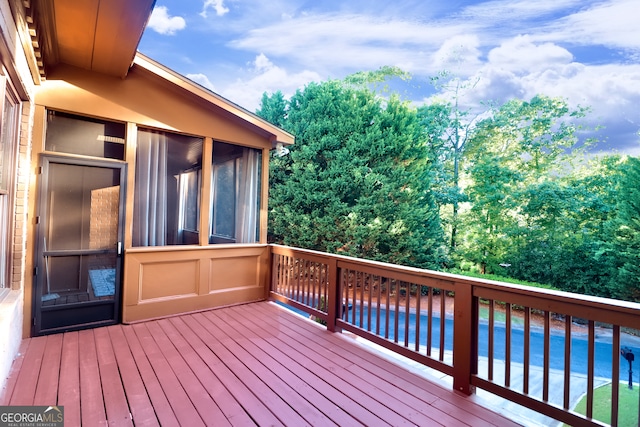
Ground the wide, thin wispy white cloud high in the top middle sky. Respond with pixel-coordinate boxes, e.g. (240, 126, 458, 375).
(230, 14, 473, 76)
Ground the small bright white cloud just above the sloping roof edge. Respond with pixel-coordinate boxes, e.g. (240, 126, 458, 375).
(220, 54, 323, 111)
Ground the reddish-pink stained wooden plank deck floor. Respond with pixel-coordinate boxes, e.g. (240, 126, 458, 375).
(0, 302, 516, 427)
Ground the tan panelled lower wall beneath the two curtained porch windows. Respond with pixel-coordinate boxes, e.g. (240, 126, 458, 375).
(123, 245, 270, 323)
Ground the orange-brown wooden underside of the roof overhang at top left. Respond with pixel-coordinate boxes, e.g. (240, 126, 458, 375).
(31, 0, 155, 77)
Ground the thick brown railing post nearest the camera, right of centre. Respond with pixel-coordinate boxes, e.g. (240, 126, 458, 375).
(453, 282, 478, 395)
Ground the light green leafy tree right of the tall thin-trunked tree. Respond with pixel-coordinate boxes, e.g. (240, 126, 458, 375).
(463, 96, 596, 284)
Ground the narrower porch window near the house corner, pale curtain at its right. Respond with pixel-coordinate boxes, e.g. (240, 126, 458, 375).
(209, 142, 262, 243)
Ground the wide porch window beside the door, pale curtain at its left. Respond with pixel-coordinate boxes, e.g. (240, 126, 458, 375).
(133, 129, 202, 246)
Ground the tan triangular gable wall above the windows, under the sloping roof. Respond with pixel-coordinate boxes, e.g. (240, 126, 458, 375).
(36, 65, 271, 148)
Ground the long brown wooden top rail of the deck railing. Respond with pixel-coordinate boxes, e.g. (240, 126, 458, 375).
(270, 244, 640, 316)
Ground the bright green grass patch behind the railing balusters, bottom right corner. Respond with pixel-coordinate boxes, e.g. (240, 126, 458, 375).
(575, 382, 639, 427)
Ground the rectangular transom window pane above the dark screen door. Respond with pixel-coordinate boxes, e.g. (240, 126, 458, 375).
(45, 111, 125, 160)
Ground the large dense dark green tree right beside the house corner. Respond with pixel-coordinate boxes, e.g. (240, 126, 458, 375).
(259, 80, 445, 268)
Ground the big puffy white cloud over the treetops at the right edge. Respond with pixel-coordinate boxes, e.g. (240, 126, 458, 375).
(440, 37, 640, 154)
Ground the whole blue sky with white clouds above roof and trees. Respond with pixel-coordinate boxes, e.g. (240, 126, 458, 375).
(139, 0, 640, 155)
